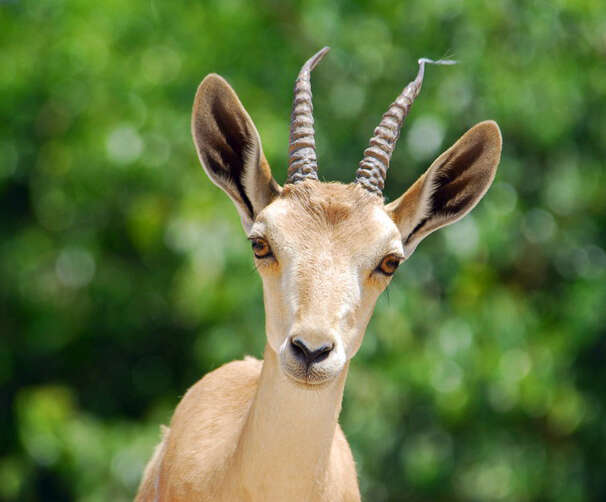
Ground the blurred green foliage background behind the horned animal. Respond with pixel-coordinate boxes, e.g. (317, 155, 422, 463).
(0, 0, 606, 502)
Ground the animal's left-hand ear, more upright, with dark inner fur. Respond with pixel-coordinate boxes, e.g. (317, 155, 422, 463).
(191, 74, 282, 232)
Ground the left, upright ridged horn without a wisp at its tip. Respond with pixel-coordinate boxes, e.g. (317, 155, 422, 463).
(286, 47, 330, 183)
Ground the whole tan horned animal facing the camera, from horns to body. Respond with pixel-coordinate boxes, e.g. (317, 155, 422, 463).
(136, 48, 501, 502)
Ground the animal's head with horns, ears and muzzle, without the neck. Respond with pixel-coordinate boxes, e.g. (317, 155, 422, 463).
(192, 48, 502, 385)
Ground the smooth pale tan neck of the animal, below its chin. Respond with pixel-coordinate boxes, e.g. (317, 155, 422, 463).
(236, 347, 348, 501)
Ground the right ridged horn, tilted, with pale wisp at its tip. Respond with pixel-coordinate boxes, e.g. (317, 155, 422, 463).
(355, 58, 456, 195)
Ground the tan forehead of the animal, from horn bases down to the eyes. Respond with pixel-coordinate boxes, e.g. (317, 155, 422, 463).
(255, 181, 399, 246)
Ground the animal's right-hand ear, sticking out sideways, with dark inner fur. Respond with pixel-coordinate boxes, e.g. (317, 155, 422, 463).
(385, 121, 502, 257)
